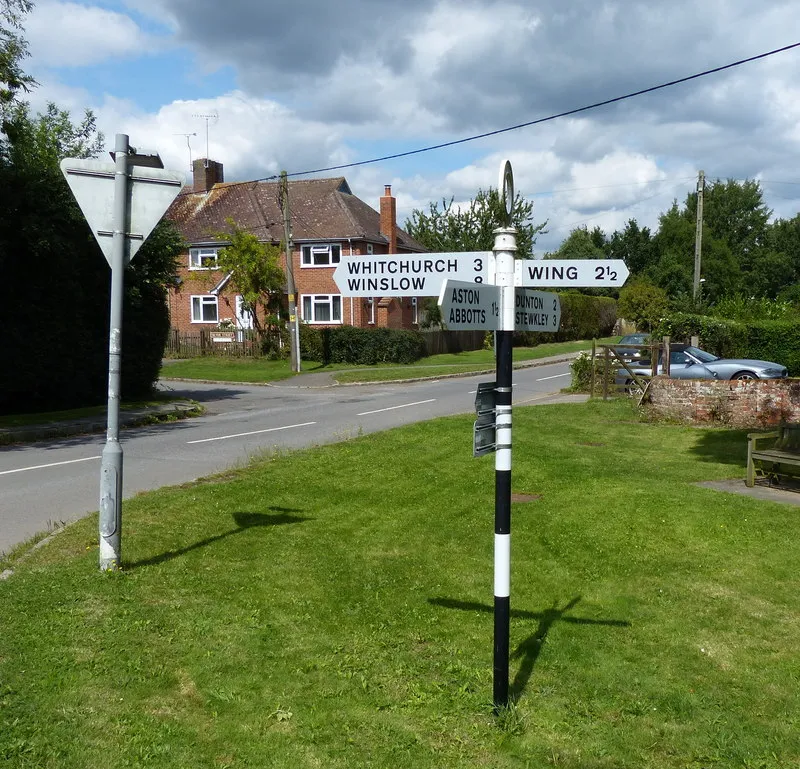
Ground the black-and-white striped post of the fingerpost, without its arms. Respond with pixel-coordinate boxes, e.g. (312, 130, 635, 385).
(494, 227, 517, 708)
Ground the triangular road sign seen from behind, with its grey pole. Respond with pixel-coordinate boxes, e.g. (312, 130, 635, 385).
(61, 134, 183, 571)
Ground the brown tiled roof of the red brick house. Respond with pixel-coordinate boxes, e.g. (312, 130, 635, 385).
(166, 176, 425, 251)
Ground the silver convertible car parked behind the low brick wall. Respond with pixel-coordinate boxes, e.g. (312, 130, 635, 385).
(616, 344, 788, 389)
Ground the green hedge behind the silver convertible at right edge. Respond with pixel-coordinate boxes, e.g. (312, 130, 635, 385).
(653, 313, 800, 376)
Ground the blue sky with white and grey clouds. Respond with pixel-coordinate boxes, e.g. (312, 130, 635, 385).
(15, 0, 800, 250)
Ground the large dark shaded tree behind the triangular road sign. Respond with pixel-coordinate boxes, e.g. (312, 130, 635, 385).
(0, 103, 181, 413)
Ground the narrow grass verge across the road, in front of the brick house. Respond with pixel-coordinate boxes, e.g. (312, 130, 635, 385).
(161, 337, 617, 383)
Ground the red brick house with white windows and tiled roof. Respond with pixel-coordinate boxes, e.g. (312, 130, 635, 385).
(161, 159, 425, 331)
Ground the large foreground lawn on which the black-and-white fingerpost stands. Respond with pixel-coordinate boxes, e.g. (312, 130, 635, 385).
(0, 400, 800, 769)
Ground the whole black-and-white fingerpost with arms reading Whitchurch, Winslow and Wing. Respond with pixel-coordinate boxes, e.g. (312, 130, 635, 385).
(333, 160, 628, 708)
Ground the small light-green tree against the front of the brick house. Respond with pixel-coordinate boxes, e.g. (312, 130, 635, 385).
(217, 219, 286, 349)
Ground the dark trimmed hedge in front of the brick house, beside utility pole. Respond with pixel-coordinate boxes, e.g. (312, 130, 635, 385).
(300, 324, 426, 366)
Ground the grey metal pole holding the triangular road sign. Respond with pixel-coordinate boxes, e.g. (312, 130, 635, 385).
(99, 134, 129, 571)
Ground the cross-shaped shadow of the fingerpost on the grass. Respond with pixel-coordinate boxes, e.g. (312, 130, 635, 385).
(428, 595, 631, 697)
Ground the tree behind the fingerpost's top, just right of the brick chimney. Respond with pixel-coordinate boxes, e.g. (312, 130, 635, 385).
(404, 187, 547, 259)
